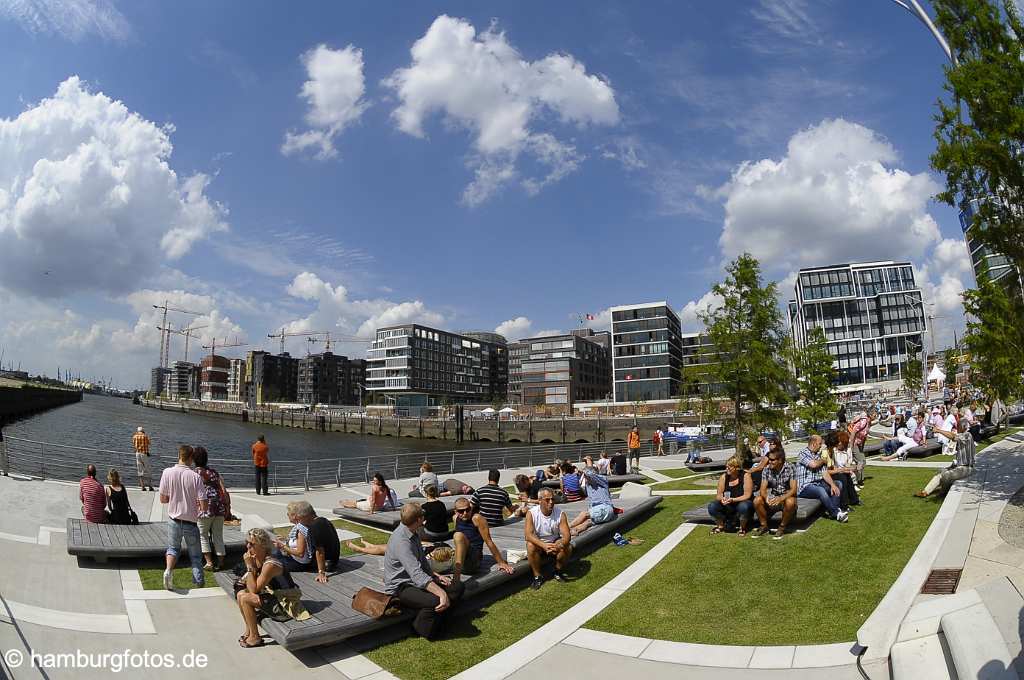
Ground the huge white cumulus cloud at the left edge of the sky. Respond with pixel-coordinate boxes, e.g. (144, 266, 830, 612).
(0, 76, 227, 297)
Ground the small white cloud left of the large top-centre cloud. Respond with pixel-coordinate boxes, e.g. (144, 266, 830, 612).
(281, 44, 369, 161)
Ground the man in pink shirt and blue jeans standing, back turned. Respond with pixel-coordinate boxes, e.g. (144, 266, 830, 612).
(160, 444, 205, 590)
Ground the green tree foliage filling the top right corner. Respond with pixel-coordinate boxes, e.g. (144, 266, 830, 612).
(931, 0, 1024, 276)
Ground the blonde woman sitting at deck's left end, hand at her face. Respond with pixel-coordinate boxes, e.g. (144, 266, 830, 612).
(234, 528, 309, 648)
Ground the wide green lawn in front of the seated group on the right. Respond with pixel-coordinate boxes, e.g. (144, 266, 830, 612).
(586, 468, 941, 645)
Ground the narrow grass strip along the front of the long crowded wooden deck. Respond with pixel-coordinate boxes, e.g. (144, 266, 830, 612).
(365, 497, 701, 680)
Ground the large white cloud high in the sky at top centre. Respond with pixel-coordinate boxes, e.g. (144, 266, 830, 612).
(384, 14, 618, 206)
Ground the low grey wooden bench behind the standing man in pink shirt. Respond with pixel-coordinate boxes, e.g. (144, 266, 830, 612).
(68, 517, 246, 562)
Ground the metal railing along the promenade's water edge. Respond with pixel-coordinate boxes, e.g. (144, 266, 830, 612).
(0, 436, 727, 491)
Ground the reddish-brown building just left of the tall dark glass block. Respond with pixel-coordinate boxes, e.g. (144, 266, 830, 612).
(520, 329, 611, 414)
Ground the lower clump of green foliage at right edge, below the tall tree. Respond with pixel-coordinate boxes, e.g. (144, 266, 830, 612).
(964, 280, 1024, 400)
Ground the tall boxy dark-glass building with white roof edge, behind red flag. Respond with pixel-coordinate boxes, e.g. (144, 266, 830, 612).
(611, 301, 683, 401)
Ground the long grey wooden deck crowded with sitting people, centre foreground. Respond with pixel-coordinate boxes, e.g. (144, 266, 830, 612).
(214, 496, 662, 650)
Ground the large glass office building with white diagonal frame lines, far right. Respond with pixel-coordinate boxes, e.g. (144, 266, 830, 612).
(788, 261, 927, 385)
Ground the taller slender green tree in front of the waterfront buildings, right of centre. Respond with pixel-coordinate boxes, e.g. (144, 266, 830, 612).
(698, 253, 790, 452)
